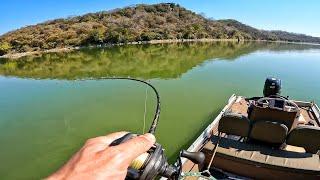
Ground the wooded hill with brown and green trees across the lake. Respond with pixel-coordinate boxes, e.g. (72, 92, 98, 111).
(0, 3, 320, 55)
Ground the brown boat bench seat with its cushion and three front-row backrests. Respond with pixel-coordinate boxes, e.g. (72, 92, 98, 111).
(201, 113, 320, 179)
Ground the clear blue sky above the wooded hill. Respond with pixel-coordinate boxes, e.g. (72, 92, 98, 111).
(0, 0, 320, 37)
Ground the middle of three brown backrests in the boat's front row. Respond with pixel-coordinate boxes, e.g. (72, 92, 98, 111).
(250, 120, 288, 145)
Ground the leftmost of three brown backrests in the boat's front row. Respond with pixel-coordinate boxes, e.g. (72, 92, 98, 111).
(218, 112, 250, 137)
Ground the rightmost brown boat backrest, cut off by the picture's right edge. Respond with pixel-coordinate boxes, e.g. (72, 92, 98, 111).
(287, 126, 320, 154)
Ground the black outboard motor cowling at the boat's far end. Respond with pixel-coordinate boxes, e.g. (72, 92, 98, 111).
(263, 77, 281, 97)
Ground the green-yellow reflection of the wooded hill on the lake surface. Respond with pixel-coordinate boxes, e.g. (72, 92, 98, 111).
(0, 42, 317, 79)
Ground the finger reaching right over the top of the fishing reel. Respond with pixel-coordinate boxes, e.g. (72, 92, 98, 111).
(110, 133, 156, 162)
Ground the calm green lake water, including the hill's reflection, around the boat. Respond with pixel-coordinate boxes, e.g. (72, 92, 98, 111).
(0, 42, 320, 179)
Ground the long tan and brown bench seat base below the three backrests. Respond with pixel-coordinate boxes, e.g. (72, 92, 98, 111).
(202, 136, 320, 179)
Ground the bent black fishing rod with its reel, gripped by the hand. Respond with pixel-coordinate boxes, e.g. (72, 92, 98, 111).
(100, 77, 205, 180)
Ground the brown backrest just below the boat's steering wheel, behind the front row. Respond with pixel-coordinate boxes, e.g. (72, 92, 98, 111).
(249, 104, 299, 130)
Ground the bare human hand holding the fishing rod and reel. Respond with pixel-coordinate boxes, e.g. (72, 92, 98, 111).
(47, 132, 156, 180)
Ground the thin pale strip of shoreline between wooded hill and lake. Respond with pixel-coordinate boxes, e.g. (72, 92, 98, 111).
(0, 39, 320, 59)
